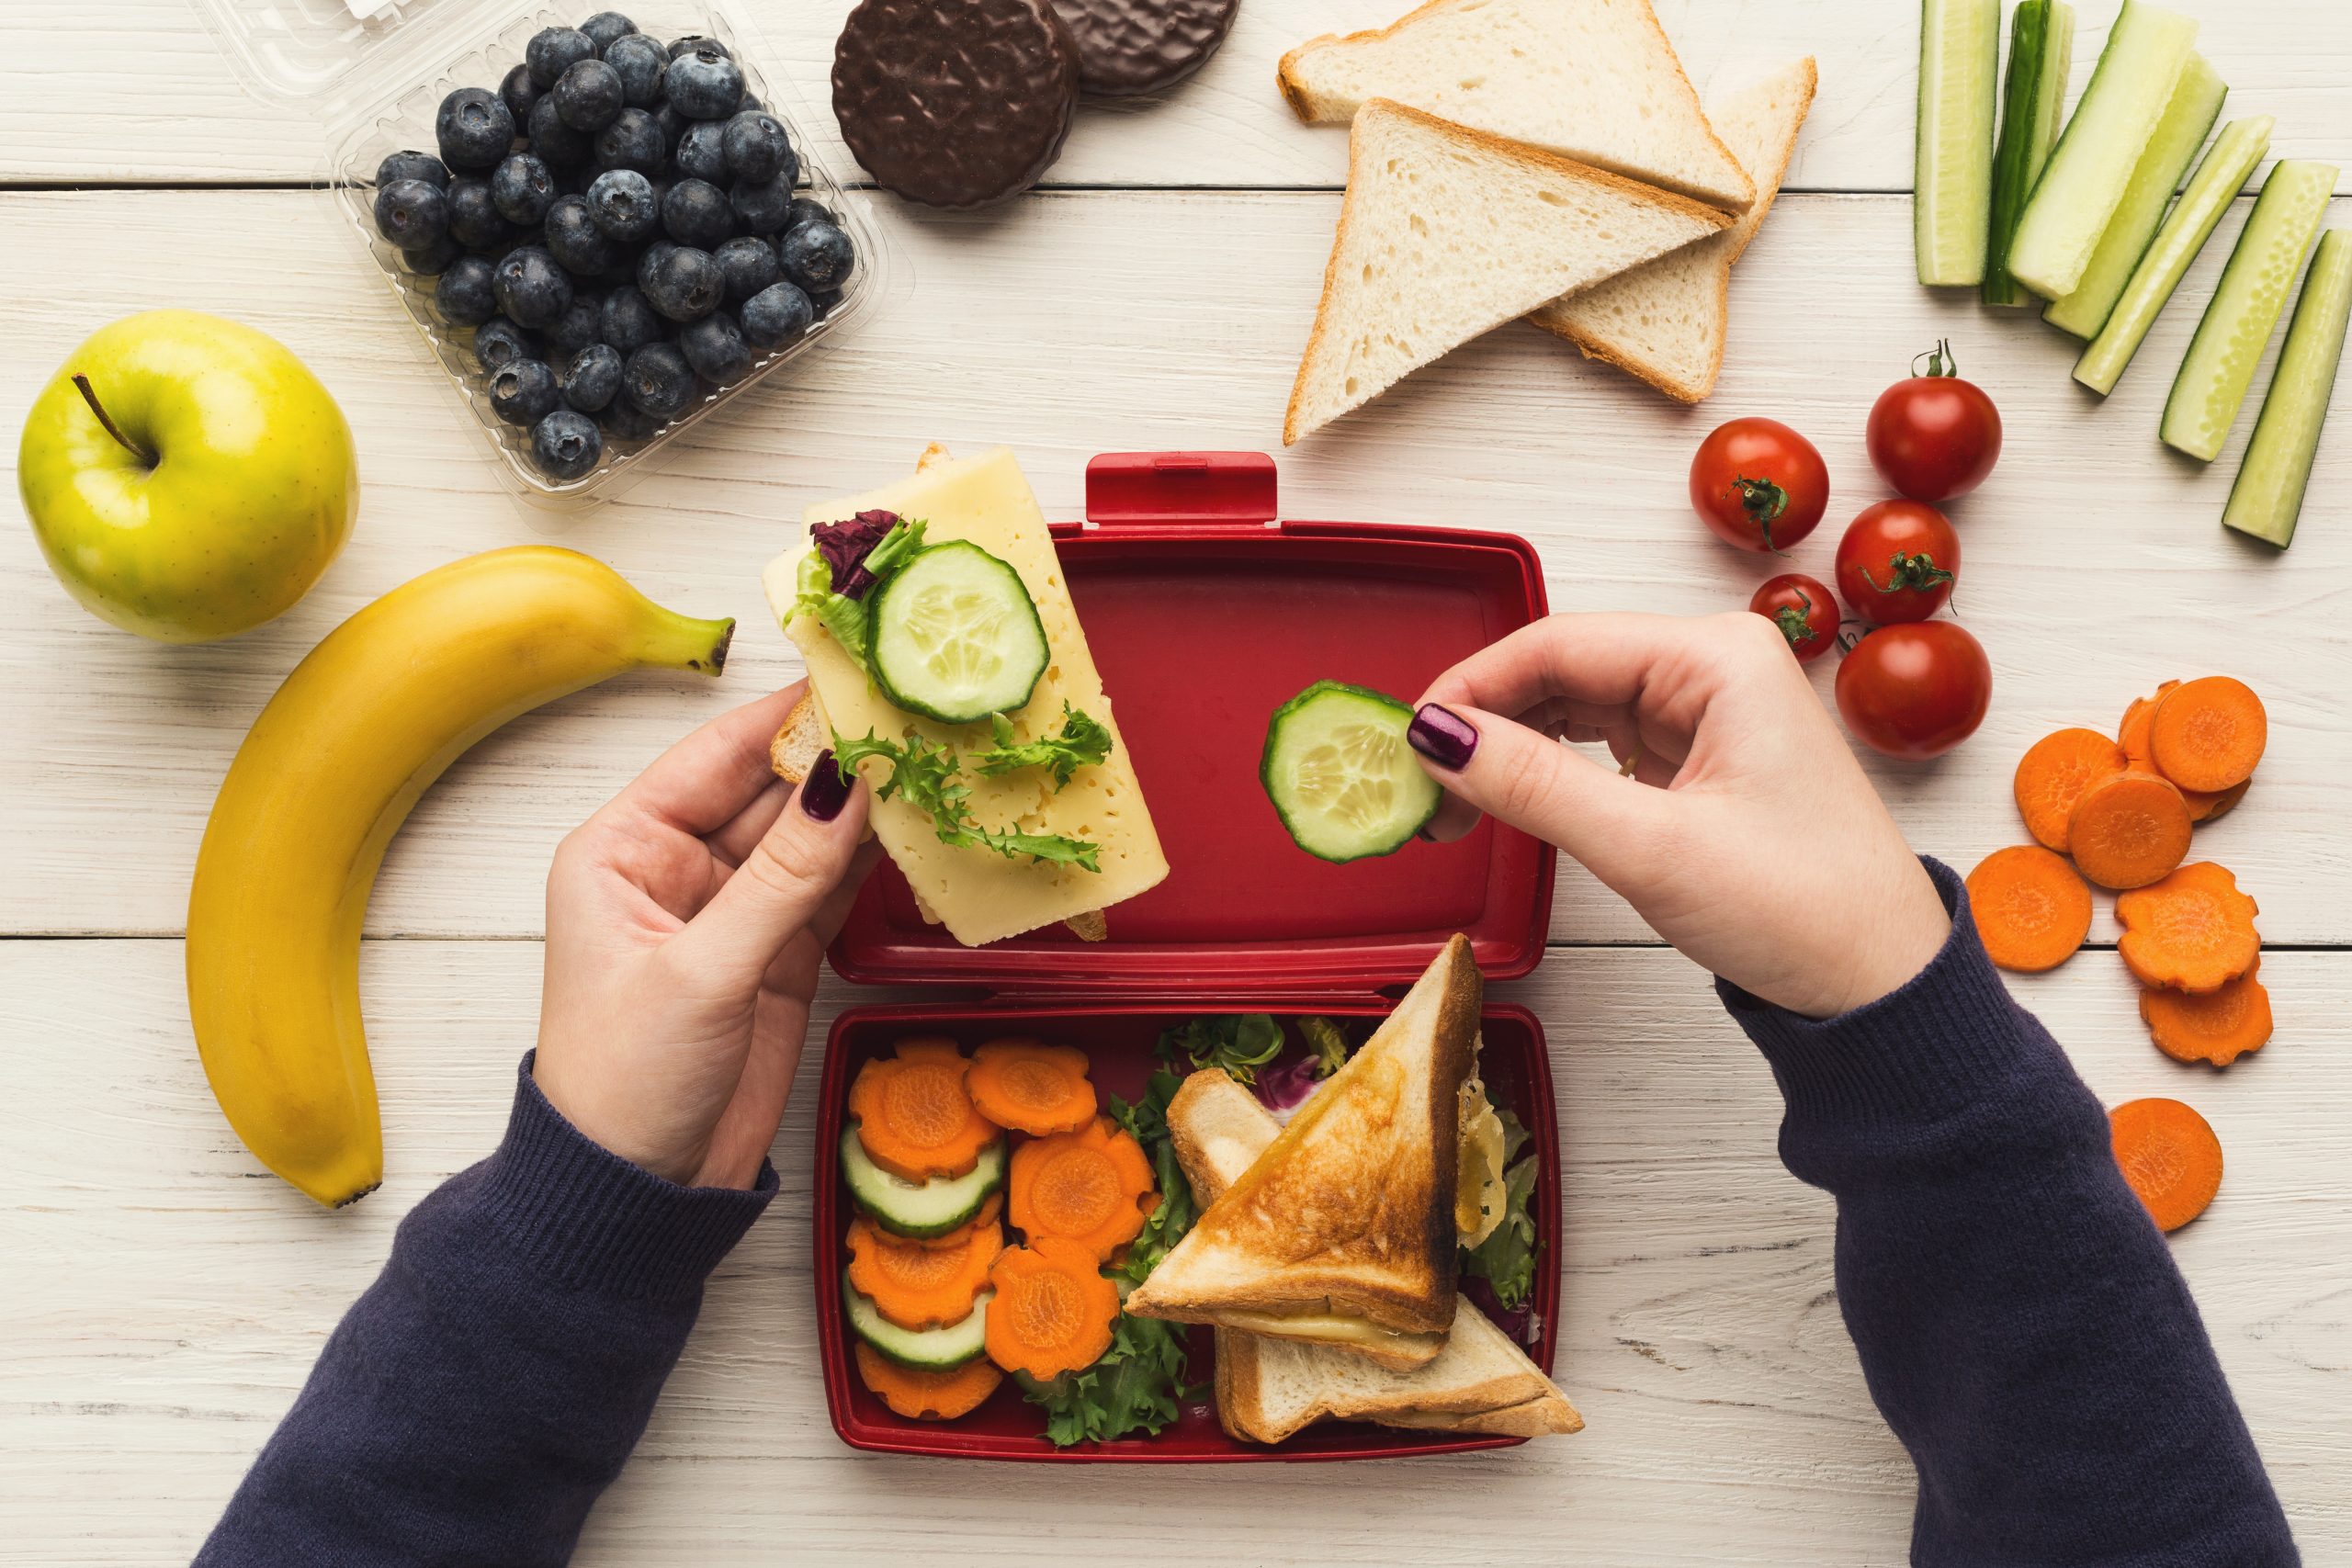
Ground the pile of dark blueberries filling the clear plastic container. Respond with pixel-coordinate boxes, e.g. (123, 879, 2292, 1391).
(362, 12, 856, 482)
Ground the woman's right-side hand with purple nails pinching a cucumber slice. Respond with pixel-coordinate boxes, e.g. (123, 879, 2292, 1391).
(1411, 614, 1952, 1018)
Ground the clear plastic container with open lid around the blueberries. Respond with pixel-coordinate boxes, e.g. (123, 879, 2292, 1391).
(178, 0, 899, 513)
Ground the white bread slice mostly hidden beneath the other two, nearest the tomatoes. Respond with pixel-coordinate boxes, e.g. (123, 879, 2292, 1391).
(1526, 59, 1818, 402)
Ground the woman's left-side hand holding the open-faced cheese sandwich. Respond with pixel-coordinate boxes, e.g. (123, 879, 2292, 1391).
(532, 686, 879, 1187)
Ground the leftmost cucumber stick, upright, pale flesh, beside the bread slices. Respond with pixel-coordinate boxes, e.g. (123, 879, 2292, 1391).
(1912, 0, 2002, 289)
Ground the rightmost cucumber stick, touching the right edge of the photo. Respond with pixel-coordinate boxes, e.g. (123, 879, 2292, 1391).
(2221, 228, 2352, 550)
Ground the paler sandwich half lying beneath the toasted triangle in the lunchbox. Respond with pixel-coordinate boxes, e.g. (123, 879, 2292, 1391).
(1167, 1067, 1585, 1443)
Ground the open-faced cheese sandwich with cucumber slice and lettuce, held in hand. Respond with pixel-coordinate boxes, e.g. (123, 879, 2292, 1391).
(762, 446, 1169, 947)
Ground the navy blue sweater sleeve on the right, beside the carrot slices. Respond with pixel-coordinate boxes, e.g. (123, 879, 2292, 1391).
(1717, 861, 2298, 1568)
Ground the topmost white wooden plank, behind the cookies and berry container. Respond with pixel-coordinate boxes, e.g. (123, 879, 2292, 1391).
(0, 0, 2352, 190)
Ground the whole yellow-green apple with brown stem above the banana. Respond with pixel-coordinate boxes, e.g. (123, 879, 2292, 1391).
(17, 310, 360, 642)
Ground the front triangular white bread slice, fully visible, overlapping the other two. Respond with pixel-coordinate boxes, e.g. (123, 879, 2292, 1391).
(1282, 98, 1731, 446)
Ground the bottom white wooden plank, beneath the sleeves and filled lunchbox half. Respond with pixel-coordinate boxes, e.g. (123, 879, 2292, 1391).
(0, 941, 2352, 1568)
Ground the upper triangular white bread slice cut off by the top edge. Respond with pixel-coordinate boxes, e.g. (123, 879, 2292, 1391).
(1275, 0, 1755, 211)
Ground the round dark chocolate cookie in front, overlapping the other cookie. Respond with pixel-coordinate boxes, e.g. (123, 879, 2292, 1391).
(832, 0, 1077, 207)
